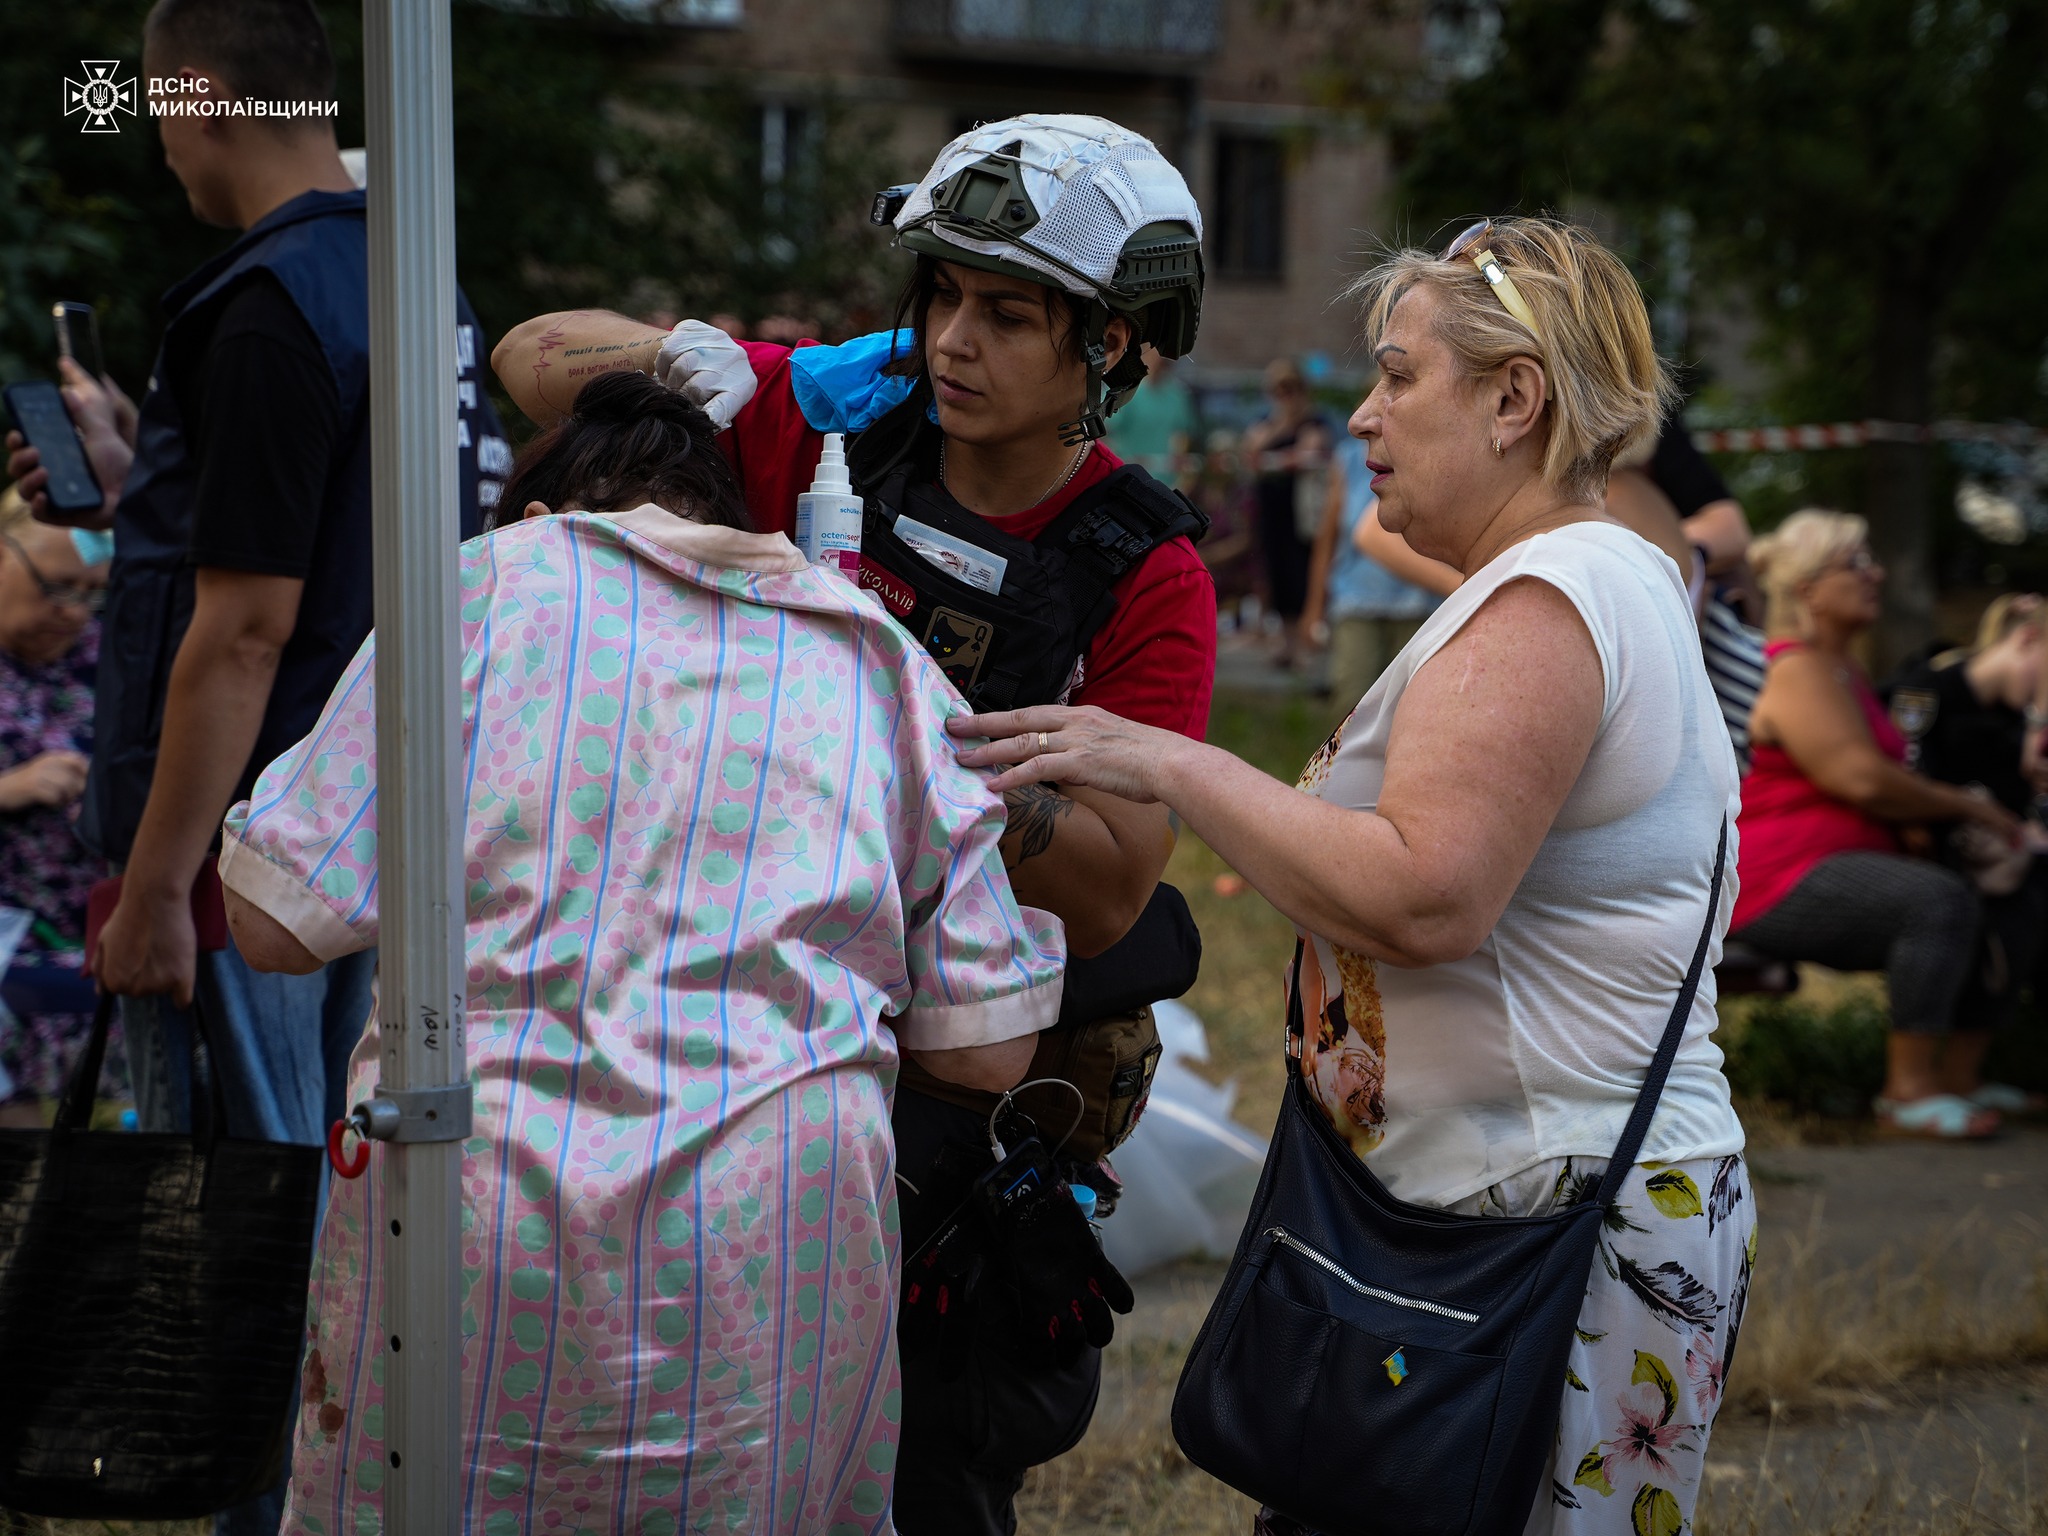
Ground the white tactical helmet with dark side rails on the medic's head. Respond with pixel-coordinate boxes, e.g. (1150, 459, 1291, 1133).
(874, 113, 1202, 442)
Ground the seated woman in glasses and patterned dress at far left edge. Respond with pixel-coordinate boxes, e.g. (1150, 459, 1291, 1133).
(0, 487, 127, 1126)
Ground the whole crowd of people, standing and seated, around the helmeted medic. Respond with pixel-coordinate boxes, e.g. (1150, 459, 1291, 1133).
(0, 0, 2048, 1536)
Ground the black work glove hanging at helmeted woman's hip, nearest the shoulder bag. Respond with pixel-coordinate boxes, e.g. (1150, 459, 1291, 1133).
(977, 1141, 1137, 1364)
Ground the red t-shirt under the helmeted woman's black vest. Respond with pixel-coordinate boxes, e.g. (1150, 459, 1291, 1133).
(719, 342, 1217, 739)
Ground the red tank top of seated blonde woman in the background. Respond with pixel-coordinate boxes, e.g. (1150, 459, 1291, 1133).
(1729, 641, 1907, 932)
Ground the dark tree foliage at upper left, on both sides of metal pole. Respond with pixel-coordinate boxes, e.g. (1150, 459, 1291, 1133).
(0, 0, 897, 428)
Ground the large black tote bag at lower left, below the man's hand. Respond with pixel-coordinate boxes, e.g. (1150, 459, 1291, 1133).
(0, 997, 322, 1520)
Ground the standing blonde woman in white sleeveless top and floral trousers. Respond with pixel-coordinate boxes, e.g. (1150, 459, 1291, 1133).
(950, 219, 1753, 1536)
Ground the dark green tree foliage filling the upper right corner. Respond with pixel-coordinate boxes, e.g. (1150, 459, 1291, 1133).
(1359, 0, 2048, 651)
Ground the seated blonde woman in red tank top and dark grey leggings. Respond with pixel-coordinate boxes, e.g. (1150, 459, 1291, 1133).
(1731, 510, 2019, 1141)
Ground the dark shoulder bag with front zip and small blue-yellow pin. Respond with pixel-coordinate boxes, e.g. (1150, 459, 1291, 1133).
(1174, 825, 1729, 1536)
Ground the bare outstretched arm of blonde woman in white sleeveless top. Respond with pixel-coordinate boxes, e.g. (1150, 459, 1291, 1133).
(946, 582, 1602, 965)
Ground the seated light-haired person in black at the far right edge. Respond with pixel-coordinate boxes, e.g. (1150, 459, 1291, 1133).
(1884, 592, 2048, 1114)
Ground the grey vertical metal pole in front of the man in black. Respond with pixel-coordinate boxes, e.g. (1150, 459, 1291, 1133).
(362, 0, 469, 1536)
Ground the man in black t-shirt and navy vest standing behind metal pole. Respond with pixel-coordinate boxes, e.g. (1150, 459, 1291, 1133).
(10, 0, 510, 1204)
